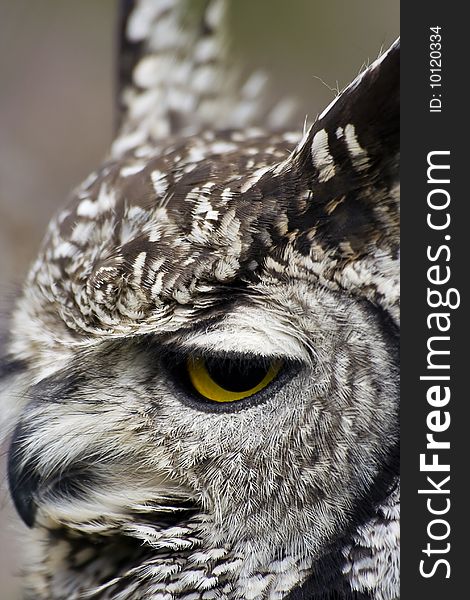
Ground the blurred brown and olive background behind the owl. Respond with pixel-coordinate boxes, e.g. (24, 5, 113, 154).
(0, 0, 399, 600)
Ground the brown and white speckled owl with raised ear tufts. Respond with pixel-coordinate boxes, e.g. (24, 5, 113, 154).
(0, 0, 399, 600)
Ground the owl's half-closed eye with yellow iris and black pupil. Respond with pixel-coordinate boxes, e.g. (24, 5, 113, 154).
(186, 357, 283, 402)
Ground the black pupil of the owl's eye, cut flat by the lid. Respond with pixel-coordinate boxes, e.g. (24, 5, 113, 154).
(205, 358, 270, 392)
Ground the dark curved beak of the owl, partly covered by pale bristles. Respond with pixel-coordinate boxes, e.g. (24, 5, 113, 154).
(8, 425, 41, 527)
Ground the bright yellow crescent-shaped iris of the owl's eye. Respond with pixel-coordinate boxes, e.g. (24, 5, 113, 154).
(186, 358, 282, 402)
